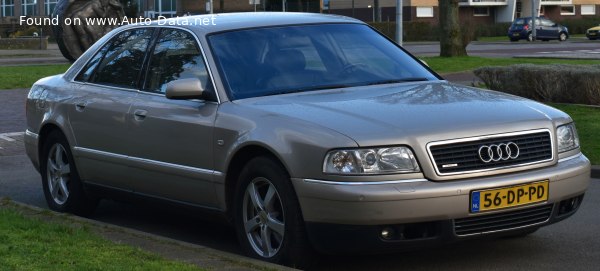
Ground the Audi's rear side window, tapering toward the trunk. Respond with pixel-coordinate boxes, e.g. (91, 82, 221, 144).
(75, 28, 153, 88)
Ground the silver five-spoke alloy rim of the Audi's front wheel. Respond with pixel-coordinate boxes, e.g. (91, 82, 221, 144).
(242, 177, 285, 258)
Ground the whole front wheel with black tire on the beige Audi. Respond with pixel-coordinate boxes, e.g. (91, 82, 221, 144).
(234, 157, 312, 266)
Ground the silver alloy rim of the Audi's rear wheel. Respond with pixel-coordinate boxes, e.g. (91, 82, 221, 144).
(46, 143, 71, 205)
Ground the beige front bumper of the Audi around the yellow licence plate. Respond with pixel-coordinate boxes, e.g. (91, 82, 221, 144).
(292, 154, 591, 254)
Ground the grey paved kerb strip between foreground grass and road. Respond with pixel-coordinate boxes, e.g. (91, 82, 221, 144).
(0, 198, 295, 270)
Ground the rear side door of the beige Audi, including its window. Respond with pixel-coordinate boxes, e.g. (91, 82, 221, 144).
(69, 28, 153, 189)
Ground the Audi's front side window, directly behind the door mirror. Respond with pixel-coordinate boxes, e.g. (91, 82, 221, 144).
(144, 29, 211, 93)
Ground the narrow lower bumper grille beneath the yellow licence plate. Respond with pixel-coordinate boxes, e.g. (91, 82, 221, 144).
(454, 204, 553, 236)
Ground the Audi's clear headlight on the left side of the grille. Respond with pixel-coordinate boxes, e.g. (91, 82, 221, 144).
(323, 147, 420, 174)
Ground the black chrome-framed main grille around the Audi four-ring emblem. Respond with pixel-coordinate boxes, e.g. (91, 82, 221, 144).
(429, 130, 553, 175)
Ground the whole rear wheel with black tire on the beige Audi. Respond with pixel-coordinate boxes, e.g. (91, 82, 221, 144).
(40, 131, 98, 216)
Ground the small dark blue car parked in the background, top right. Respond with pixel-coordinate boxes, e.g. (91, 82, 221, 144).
(508, 17, 569, 41)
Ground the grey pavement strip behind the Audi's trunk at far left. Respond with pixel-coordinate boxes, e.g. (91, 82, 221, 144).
(0, 43, 69, 66)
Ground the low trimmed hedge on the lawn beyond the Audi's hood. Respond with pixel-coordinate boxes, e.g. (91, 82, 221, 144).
(474, 64, 600, 105)
